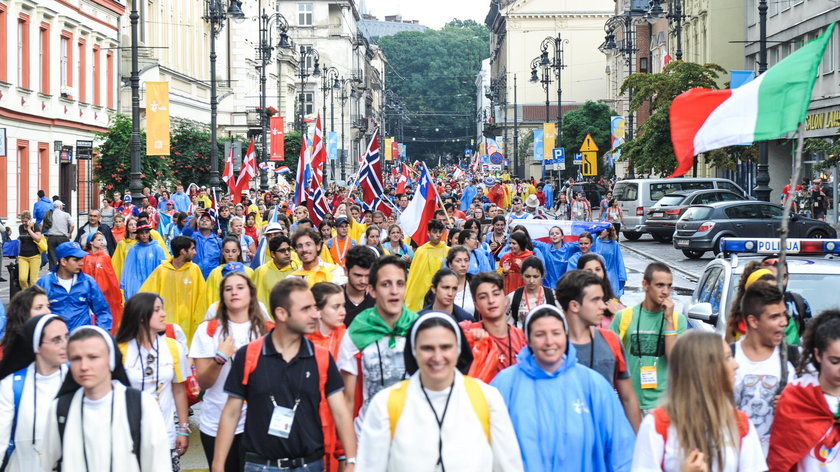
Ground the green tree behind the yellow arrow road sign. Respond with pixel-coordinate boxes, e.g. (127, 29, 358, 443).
(562, 101, 616, 176)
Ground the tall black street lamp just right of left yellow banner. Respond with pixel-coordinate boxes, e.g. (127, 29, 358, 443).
(204, 0, 245, 195)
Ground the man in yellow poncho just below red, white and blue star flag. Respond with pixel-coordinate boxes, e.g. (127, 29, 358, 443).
(405, 219, 449, 312)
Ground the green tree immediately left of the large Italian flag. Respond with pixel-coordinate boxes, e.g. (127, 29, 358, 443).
(620, 61, 726, 175)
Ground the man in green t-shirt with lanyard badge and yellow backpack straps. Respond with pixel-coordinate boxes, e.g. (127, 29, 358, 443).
(610, 262, 687, 413)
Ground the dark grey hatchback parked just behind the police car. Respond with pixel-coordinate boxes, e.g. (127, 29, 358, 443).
(674, 200, 837, 259)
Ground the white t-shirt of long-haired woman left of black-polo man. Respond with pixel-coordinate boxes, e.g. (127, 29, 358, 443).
(190, 321, 256, 436)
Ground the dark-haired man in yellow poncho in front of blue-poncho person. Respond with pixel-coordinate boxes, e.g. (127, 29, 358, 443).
(140, 236, 207, 341)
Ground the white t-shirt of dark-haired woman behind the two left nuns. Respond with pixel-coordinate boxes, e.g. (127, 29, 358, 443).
(123, 335, 190, 449)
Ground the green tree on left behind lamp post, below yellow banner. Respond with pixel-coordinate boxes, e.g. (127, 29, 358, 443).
(93, 114, 172, 195)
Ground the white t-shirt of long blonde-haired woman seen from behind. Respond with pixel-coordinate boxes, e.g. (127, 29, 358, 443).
(631, 415, 767, 472)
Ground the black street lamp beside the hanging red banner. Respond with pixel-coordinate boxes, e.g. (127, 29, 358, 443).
(257, 1, 292, 192)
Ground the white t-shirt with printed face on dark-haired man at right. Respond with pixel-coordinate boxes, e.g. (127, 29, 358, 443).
(734, 339, 795, 456)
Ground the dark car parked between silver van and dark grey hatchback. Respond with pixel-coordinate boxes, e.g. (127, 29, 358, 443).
(643, 189, 744, 243)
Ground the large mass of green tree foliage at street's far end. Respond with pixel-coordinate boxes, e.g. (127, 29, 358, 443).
(379, 19, 490, 157)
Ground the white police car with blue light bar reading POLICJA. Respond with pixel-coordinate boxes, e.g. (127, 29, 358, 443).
(686, 238, 840, 335)
